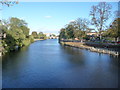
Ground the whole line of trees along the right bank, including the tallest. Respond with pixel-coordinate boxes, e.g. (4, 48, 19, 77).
(59, 2, 120, 41)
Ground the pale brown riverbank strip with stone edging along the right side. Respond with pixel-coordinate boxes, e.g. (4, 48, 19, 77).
(60, 41, 120, 56)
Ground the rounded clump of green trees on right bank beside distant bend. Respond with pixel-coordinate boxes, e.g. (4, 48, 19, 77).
(59, 18, 89, 39)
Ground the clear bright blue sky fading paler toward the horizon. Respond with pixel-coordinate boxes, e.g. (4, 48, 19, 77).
(0, 2, 118, 34)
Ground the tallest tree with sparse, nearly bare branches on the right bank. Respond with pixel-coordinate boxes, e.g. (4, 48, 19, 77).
(90, 2, 111, 39)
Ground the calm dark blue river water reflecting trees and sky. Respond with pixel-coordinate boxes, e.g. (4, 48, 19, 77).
(2, 39, 118, 88)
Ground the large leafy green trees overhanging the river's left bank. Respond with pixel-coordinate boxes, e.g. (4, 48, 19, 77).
(2, 17, 33, 51)
